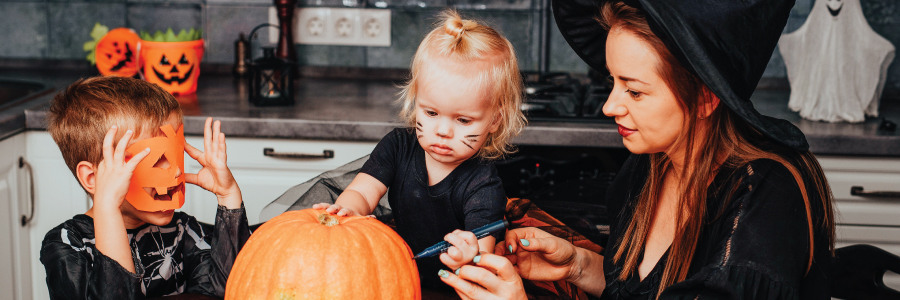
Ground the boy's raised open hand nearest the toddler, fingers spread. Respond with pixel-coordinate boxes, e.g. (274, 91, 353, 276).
(184, 118, 243, 209)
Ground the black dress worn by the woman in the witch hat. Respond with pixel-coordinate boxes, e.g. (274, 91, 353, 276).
(601, 155, 831, 300)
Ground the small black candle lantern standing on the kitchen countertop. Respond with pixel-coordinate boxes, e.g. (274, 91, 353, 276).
(249, 47, 295, 106)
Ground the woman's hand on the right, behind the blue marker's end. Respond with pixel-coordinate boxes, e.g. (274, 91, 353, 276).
(494, 227, 580, 281)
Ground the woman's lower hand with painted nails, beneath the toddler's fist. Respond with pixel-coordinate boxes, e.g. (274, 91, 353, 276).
(438, 253, 527, 300)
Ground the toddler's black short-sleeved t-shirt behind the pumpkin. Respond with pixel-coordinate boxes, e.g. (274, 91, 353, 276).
(360, 128, 506, 288)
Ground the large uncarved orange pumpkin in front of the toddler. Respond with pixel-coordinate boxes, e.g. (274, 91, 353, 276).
(225, 209, 422, 300)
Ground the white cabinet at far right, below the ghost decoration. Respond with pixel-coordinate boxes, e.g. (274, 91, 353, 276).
(818, 156, 900, 289)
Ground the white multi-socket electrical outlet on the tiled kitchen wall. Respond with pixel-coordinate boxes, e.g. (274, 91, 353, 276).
(269, 7, 391, 47)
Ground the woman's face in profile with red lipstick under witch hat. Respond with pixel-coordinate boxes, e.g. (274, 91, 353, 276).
(603, 28, 685, 154)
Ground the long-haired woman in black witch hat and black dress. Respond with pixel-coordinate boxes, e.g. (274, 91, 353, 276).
(441, 0, 834, 299)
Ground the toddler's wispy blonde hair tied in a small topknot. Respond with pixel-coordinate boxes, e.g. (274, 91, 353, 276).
(400, 10, 525, 159)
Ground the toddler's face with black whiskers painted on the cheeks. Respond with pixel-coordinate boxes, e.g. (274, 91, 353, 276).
(416, 58, 499, 164)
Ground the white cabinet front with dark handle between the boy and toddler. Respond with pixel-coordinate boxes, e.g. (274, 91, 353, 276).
(182, 136, 377, 224)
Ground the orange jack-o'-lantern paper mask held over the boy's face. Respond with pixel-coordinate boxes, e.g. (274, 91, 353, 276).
(125, 125, 184, 212)
